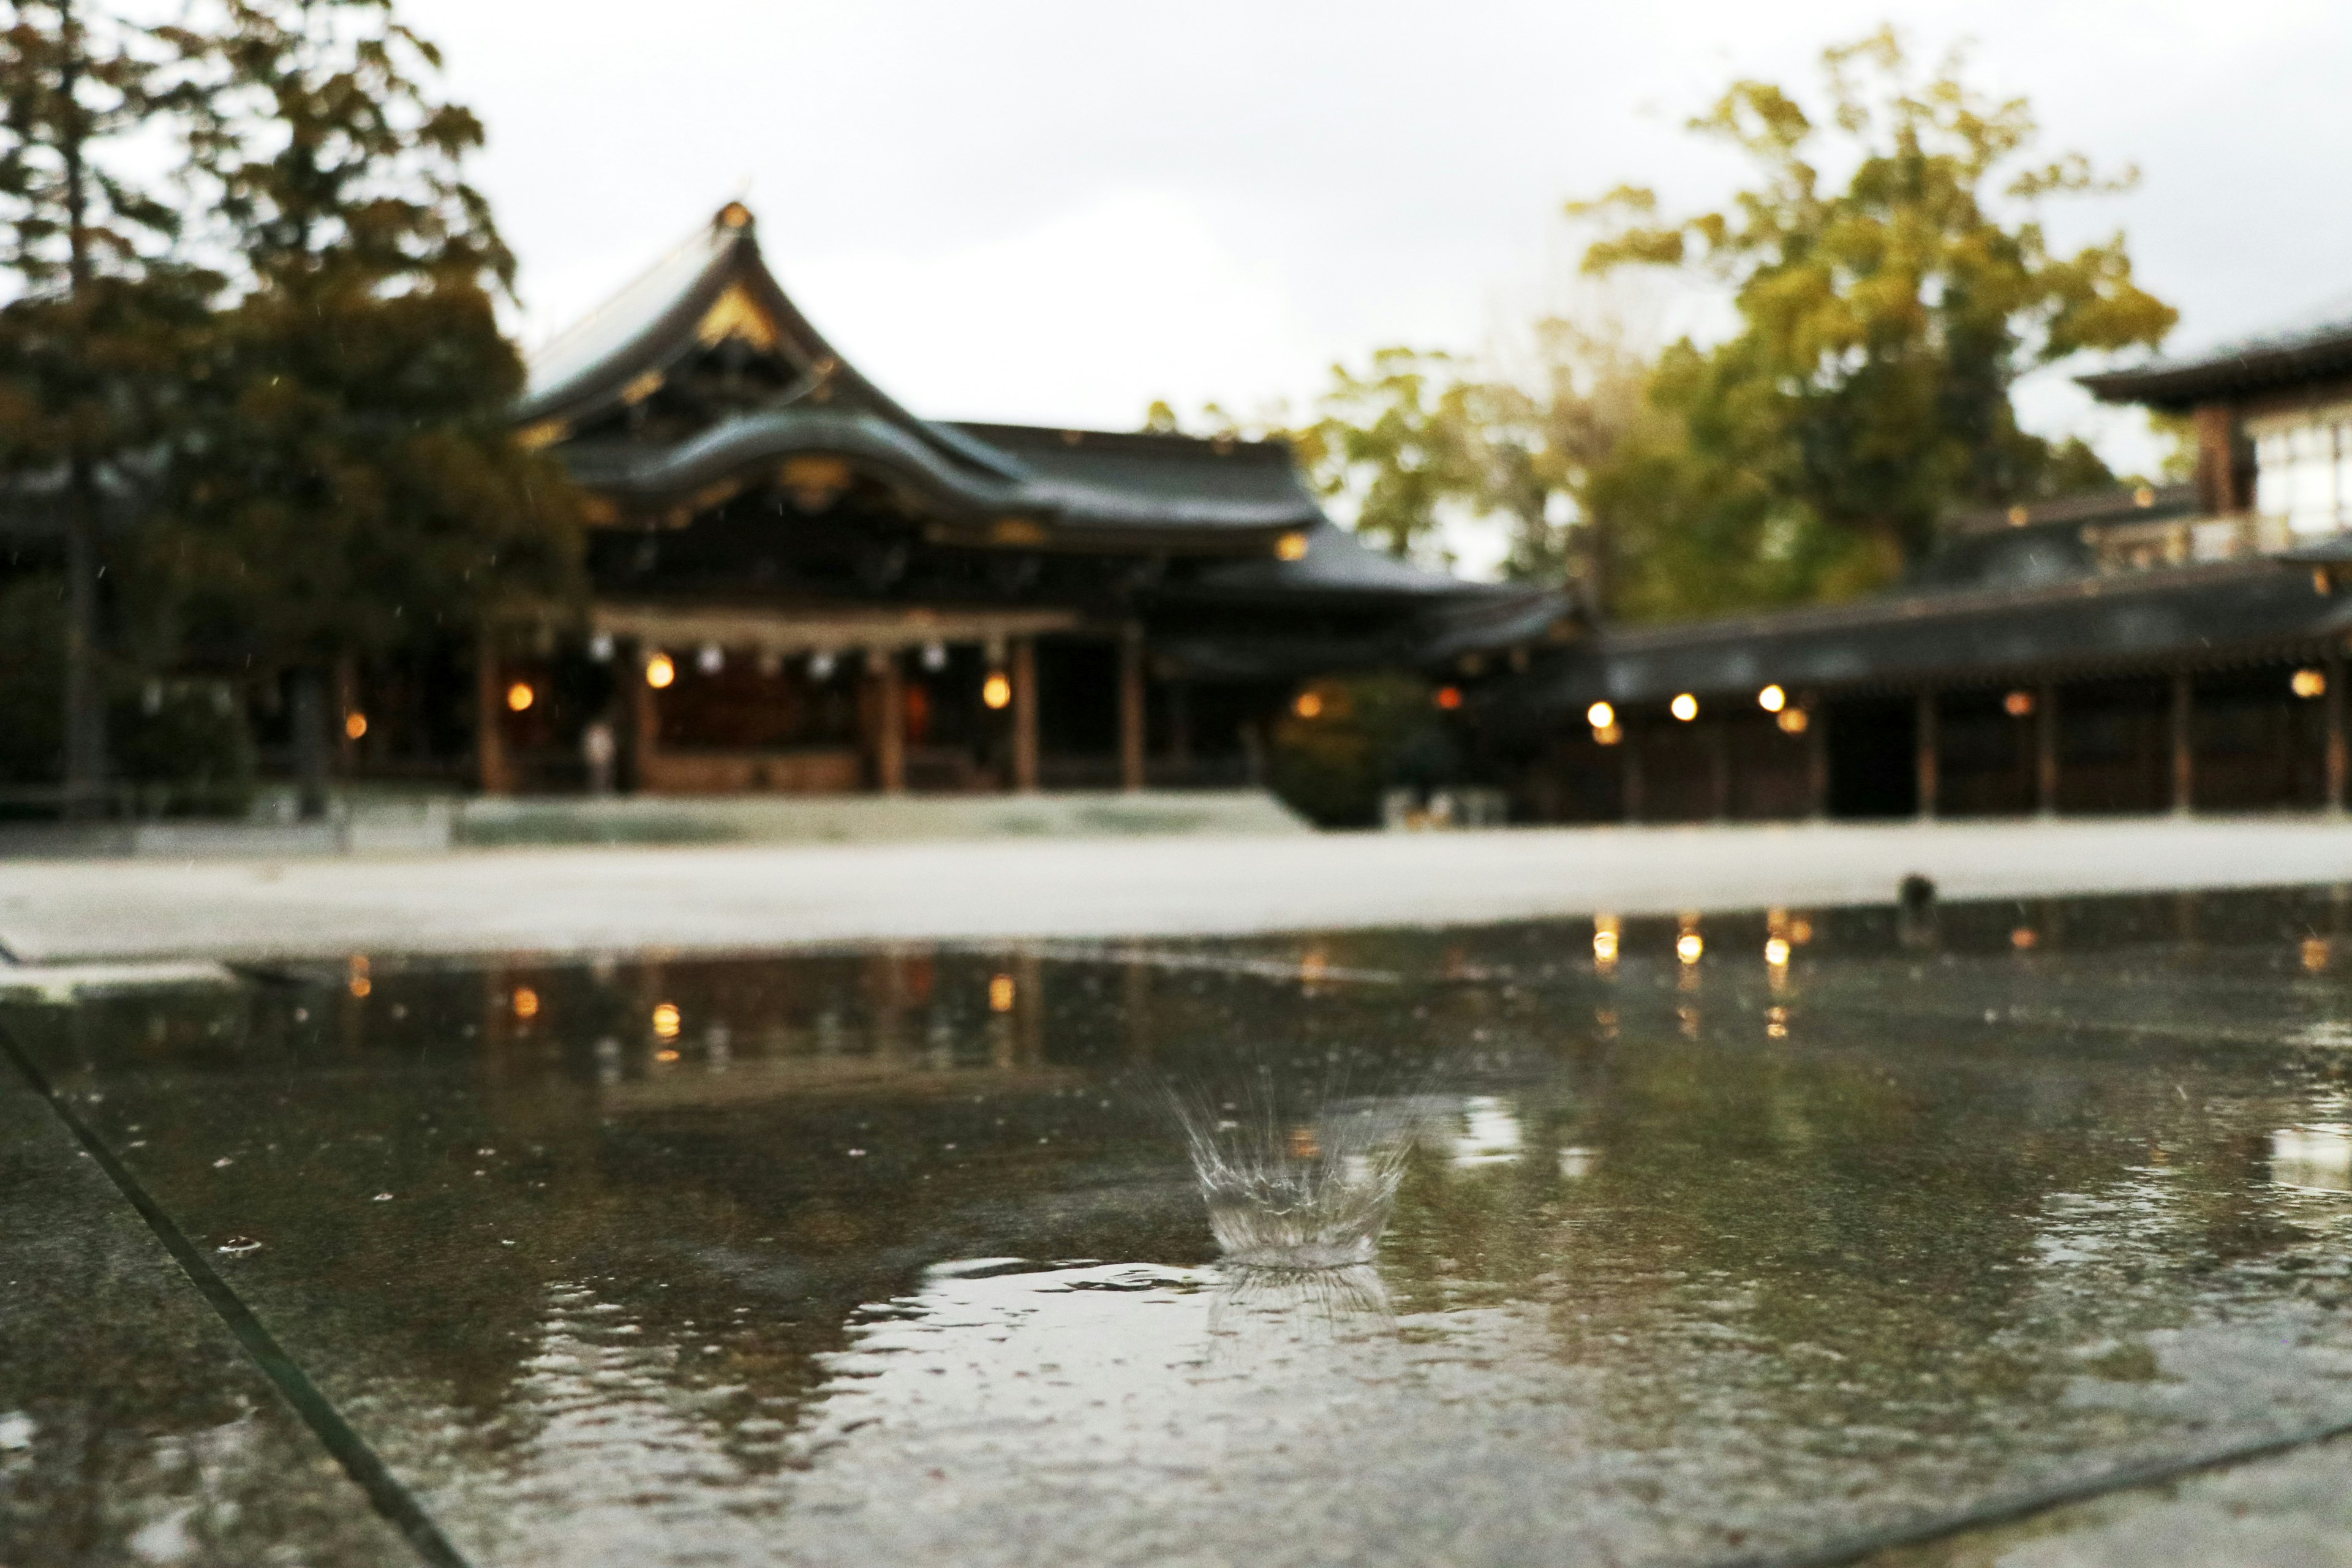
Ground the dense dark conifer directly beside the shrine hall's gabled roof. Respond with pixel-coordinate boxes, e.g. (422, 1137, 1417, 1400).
(162, 0, 581, 813)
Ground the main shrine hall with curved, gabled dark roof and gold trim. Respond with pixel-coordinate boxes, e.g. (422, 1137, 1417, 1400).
(442, 205, 1574, 794)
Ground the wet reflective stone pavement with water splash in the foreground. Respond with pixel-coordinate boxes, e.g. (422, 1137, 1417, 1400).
(0, 889, 2352, 1568)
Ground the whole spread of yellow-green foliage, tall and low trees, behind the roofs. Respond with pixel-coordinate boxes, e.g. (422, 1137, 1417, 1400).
(1194, 31, 2176, 620)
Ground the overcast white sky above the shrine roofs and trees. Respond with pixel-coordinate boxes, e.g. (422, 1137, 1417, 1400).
(404, 0, 2352, 472)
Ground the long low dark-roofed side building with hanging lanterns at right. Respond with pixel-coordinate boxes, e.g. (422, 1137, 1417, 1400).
(1475, 305, 2352, 823)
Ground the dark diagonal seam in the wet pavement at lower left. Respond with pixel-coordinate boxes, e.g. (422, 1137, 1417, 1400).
(0, 1027, 473, 1568)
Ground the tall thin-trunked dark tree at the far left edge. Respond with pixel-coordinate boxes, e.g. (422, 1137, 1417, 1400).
(0, 0, 216, 816)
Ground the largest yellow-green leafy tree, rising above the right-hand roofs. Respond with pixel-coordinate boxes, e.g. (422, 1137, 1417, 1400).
(1571, 31, 2176, 582)
